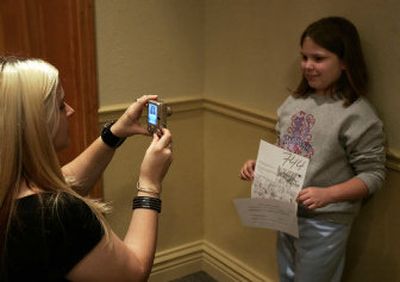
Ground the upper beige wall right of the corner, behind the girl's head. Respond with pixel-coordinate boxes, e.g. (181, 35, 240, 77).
(204, 0, 400, 153)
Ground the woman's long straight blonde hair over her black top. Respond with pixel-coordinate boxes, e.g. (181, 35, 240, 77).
(0, 57, 107, 254)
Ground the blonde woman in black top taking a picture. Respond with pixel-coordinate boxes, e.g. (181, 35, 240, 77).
(0, 57, 172, 281)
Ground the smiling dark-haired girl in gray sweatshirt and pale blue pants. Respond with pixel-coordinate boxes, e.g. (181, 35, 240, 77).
(241, 17, 385, 282)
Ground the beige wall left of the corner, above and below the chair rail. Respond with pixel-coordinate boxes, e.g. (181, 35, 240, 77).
(95, 0, 204, 250)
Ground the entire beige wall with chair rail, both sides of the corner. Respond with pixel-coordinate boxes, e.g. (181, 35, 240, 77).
(95, 0, 400, 281)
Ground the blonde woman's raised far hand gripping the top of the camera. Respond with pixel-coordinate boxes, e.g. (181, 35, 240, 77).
(111, 95, 157, 138)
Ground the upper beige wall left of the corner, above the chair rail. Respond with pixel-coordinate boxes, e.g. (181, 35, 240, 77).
(95, 0, 204, 106)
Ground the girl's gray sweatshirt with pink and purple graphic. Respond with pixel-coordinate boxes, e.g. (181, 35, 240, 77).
(276, 94, 385, 223)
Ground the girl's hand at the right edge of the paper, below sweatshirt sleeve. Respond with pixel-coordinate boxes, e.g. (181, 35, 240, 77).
(297, 187, 332, 210)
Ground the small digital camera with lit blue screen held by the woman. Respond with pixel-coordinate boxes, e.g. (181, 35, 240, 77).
(147, 100, 172, 134)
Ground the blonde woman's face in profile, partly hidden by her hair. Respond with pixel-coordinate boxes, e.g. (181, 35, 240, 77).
(53, 85, 75, 151)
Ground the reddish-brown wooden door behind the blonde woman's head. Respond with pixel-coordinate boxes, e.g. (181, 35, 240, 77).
(0, 0, 102, 197)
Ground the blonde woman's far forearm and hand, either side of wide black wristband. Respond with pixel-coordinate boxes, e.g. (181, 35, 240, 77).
(62, 95, 157, 195)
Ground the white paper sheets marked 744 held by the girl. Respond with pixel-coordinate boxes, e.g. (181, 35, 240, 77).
(235, 140, 309, 237)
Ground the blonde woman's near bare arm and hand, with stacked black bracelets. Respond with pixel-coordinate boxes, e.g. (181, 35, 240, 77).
(67, 129, 172, 281)
